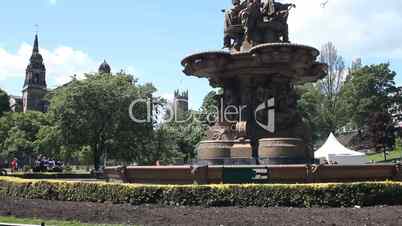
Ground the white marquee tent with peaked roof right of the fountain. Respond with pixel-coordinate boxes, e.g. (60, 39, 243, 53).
(314, 133, 369, 165)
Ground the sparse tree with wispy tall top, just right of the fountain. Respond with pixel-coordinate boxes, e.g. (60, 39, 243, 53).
(298, 42, 357, 143)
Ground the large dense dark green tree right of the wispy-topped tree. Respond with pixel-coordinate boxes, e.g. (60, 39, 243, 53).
(342, 64, 402, 150)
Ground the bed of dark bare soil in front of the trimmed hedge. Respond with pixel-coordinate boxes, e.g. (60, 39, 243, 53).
(0, 198, 402, 226)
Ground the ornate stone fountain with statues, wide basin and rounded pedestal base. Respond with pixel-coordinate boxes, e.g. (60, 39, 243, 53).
(182, 0, 327, 165)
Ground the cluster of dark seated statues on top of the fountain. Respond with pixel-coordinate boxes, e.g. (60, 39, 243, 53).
(224, 0, 296, 51)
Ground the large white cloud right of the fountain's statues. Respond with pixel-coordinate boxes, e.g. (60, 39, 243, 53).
(285, 0, 402, 59)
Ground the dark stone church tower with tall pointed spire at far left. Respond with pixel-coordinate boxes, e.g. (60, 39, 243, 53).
(22, 34, 48, 112)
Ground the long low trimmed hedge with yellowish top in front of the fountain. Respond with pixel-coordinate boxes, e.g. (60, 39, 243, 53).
(0, 177, 402, 207)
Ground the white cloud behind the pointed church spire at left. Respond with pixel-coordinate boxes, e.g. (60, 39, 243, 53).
(0, 43, 100, 88)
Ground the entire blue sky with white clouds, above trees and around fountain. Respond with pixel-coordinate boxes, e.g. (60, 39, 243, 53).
(0, 0, 402, 107)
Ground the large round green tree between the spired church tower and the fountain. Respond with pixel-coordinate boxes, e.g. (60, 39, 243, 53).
(50, 73, 156, 170)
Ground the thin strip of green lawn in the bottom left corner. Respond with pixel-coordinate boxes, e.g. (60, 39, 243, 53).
(0, 216, 121, 226)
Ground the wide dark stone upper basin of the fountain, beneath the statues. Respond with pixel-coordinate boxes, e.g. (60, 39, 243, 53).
(182, 43, 328, 84)
